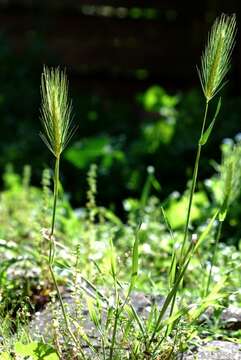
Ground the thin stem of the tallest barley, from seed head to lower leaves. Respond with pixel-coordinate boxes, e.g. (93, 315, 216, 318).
(181, 101, 209, 262)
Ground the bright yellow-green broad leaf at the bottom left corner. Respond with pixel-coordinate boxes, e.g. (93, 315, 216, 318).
(15, 342, 59, 360)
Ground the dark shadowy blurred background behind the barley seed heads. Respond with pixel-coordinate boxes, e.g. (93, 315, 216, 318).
(0, 0, 241, 209)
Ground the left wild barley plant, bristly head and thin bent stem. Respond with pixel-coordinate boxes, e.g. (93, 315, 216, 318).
(40, 67, 84, 358)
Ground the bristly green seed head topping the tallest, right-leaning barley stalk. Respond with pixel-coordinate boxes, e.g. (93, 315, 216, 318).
(198, 14, 236, 102)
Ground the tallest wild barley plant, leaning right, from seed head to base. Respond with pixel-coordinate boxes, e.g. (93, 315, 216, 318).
(147, 14, 236, 351)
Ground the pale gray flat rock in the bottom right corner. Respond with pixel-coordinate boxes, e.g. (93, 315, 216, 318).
(182, 340, 241, 360)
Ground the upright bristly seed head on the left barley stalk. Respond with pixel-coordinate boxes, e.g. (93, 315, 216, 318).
(40, 67, 74, 158)
